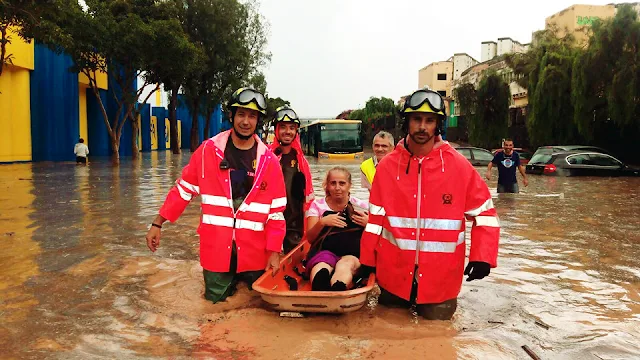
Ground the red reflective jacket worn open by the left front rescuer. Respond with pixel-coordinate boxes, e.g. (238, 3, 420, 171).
(160, 130, 287, 272)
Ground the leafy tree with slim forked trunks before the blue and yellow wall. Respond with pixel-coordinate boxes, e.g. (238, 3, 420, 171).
(42, 0, 198, 161)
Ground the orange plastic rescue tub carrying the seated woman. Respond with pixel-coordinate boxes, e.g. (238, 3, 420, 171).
(253, 241, 376, 313)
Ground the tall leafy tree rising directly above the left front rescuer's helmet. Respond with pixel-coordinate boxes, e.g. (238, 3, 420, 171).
(174, 0, 271, 150)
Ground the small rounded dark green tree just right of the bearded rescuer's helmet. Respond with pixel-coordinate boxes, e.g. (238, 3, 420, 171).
(463, 73, 511, 149)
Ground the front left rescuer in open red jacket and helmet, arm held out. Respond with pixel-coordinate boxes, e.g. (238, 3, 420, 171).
(147, 88, 287, 303)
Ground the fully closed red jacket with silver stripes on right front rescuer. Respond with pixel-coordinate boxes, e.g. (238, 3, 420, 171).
(360, 142, 500, 304)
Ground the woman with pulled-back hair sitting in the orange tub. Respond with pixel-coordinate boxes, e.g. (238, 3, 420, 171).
(306, 166, 369, 291)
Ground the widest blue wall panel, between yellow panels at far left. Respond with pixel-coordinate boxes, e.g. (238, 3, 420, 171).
(30, 44, 80, 161)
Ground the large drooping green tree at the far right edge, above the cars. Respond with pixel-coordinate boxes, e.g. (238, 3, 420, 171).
(572, 5, 640, 155)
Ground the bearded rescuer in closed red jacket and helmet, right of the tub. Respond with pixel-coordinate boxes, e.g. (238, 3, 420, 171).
(360, 90, 500, 320)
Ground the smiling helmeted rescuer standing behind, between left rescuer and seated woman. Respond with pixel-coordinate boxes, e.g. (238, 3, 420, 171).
(271, 105, 314, 254)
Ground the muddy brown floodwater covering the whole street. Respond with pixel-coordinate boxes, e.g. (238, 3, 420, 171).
(0, 152, 640, 360)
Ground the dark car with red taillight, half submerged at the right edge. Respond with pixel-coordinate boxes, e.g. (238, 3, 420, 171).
(526, 151, 640, 176)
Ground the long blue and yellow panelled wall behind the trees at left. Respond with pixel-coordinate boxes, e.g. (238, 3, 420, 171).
(0, 31, 225, 163)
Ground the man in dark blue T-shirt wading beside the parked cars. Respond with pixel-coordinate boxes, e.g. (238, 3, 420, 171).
(486, 139, 529, 193)
